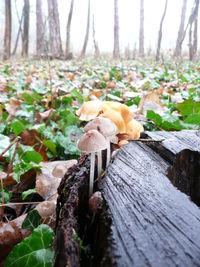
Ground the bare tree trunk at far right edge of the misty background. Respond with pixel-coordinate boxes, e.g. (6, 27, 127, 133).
(189, 0, 199, 60)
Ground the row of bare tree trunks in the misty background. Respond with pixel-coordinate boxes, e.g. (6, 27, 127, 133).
(0, 0, 199, 61)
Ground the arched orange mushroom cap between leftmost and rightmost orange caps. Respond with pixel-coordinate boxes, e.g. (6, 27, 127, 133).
(102, 101, 133, 124)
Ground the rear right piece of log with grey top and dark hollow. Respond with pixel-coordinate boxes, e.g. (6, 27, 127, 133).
(147, 131, 200, 206)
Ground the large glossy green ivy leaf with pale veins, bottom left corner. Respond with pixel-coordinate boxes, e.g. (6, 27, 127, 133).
(4, 224, 54, 267)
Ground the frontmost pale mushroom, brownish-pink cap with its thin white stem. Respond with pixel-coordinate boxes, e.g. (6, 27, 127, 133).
(78, 130, 108, 197)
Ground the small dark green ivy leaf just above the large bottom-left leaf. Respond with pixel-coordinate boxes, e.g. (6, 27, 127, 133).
(22, 210, 42, 232)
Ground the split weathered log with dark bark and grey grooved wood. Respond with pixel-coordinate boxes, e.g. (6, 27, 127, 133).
(55, 132, 200, 267)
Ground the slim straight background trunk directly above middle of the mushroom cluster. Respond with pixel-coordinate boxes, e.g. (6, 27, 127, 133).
(113, 0, 120, 59)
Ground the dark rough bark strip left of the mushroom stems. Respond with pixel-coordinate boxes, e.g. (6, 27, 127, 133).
(54, 157, 90, 267)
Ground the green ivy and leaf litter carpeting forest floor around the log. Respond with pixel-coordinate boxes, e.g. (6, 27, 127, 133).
(0, 60, 200, 266)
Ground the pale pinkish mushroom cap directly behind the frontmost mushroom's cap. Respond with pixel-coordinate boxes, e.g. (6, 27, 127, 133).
(84, 117, 117, 137)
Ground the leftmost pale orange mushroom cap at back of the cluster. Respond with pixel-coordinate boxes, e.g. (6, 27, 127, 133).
(76, 101, 102, 121)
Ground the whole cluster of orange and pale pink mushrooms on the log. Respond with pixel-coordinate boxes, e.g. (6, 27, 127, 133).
(76, 101, 144, 196)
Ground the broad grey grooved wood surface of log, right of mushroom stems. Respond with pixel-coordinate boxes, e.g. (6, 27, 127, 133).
(102, 141, 200, 267)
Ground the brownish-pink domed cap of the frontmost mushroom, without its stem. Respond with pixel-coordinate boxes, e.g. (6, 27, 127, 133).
(78, 130, 108, 153)
